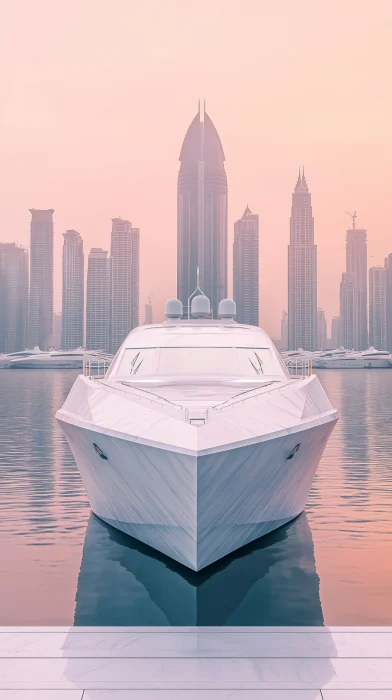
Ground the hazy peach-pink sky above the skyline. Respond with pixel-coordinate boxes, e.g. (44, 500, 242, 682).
(0, 0, 392, 335)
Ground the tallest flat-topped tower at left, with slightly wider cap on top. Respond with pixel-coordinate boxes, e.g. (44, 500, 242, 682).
(28, 209, 54, 350)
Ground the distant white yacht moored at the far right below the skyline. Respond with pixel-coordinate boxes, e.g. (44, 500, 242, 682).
(312, 347, 392, 369)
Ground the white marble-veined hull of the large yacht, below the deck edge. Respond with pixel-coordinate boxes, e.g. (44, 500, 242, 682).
(58, 411, 337, 571)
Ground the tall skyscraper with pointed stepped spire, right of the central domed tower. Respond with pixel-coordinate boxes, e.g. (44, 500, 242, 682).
(288, 171, 317, 350)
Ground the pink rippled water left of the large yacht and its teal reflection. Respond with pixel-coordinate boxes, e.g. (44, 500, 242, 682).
(0, 370, 90, 625)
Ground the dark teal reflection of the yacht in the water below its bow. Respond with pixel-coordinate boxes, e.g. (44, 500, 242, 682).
(74, 513, 324, 626)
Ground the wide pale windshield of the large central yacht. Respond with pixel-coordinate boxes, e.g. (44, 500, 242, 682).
(110, 347, 286, 377)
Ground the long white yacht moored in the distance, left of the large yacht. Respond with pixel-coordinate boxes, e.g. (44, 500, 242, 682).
(9, 348, 112, 369)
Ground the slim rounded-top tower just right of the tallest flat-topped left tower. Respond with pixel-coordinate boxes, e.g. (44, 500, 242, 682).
(61, 230, 84, 350)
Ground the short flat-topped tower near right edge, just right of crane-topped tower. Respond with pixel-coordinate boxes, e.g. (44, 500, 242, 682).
(369, 266, 387, 350)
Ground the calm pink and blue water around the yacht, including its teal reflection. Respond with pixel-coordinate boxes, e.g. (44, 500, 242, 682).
(0, 370, 392, 625)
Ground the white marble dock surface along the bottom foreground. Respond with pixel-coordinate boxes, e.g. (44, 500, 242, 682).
(0, 627, 392, 700)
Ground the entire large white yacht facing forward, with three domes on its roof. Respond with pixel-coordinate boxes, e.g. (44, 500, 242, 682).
(56, 295, 338, 570)
